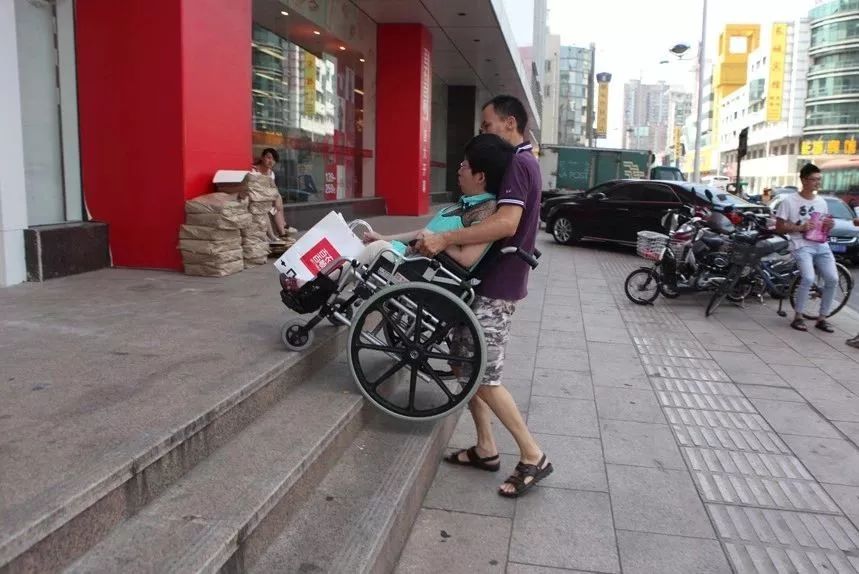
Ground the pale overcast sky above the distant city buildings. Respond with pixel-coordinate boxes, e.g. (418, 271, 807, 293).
(504, 0, 820, 147)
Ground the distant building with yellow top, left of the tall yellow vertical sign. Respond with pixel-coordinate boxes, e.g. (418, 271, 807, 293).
(684, 24, 761, 176)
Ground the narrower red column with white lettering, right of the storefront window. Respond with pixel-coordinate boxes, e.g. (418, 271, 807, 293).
(376, 24, 432, 215)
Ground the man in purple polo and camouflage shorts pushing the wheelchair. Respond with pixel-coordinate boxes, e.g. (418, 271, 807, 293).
(418, 96, 553, 497)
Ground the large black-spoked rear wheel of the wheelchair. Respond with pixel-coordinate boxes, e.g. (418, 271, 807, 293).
(347, 283, 486, 420)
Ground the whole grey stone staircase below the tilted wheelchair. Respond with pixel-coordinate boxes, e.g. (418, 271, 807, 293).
(0, 329, 458, 574)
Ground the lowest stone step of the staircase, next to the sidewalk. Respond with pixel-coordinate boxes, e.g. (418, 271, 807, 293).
(249, 414, 459, 574)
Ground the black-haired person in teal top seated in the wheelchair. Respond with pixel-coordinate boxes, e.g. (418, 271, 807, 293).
(357, 134, 514, 269)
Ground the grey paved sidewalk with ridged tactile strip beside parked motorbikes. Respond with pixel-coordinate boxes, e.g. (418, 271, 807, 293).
(398, 232, 859, 574)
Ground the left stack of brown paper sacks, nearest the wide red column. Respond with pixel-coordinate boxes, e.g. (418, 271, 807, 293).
(179, 193, 252, 277)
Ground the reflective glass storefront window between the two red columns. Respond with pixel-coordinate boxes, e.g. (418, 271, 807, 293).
(252, 24, 364, 202)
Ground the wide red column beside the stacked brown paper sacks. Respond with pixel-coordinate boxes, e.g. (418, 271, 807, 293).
(75, 0, 251, 269)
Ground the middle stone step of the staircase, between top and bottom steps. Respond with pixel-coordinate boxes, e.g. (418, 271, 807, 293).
(67, 354, 369, 574)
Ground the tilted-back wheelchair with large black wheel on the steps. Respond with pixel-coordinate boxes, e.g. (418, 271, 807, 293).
(279, 221, 540, 421)
